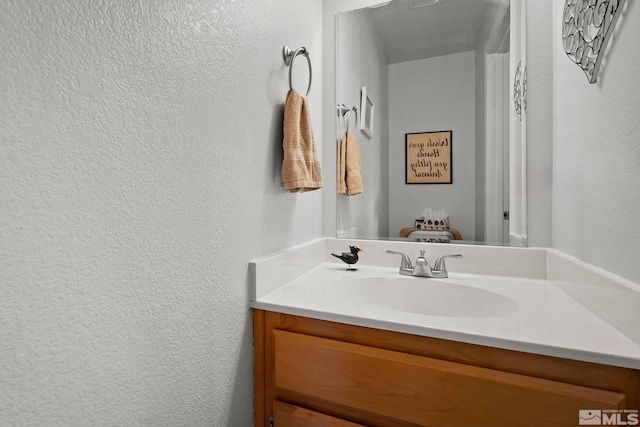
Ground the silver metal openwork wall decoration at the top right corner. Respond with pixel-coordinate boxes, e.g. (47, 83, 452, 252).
(562, 0, 625, 83)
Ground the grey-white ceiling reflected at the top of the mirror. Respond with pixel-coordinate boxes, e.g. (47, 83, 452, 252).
(370, 0, 509, 64)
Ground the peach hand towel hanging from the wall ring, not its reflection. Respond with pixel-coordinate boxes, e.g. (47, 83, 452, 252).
(282, 90, 322, 193)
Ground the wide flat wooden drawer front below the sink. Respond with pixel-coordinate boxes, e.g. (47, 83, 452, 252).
(273, 330, 626, 426)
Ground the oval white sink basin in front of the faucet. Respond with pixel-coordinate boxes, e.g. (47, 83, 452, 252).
(336, 277, 518, 317)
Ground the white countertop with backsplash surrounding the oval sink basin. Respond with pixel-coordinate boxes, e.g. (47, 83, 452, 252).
(250, 241, 640, 369)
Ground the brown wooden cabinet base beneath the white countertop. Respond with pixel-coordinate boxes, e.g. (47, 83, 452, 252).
(254, 310, 640, 427)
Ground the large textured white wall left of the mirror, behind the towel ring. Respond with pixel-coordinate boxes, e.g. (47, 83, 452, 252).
(0, 0, 322, 427)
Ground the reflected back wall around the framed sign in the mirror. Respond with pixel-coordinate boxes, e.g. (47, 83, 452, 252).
(389, 51, 476, 240)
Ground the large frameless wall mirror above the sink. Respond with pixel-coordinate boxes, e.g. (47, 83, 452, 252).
(330, 0, 527, 246)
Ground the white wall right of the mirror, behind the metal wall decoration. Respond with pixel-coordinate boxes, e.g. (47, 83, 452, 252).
(553, 1, 640, 283)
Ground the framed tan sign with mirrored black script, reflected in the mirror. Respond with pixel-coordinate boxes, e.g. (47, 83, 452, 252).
(405, 130, 453, 184)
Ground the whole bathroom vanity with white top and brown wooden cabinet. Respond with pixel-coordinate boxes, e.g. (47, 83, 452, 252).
(251, 239, 640, 427)
